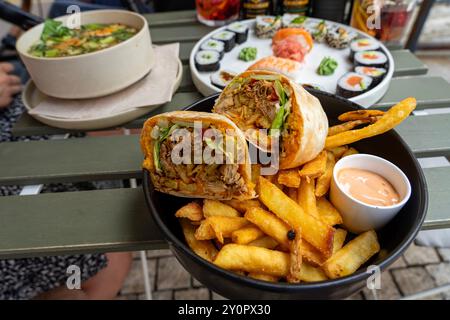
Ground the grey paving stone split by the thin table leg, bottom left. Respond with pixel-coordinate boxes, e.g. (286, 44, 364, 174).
(120, 260, 156, 294)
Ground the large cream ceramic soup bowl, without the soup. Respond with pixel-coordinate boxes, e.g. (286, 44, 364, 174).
(16, 10, 155, 99)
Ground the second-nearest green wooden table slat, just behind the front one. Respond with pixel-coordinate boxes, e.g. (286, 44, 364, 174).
(0, 113, 450, 185)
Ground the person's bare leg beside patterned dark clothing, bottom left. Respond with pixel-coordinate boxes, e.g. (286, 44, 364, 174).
(36, 252, 132, 300)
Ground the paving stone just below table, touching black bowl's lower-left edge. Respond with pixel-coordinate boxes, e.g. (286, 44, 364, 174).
(157, 257, 191, 290)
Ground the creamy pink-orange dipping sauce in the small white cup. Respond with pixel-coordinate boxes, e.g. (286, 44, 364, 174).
(338, 168, 400, 207)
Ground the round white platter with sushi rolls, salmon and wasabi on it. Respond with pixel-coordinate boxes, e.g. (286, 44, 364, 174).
(190, 14, 394, 108)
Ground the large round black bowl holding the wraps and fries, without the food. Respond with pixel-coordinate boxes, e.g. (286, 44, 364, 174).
(143, 90, 428, 300)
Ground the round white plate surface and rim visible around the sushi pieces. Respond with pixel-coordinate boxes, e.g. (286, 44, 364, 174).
(189, 17, 394, 108)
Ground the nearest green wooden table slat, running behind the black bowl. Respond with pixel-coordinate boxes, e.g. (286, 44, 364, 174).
(0, 164, 450, 259)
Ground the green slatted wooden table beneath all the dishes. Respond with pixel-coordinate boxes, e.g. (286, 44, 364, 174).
(0, 11, 450, 259)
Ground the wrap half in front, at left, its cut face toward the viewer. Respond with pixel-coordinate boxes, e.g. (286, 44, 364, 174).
(141, 111, 256, 200)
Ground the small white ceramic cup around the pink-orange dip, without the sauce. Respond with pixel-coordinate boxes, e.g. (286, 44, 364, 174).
(330, 154, 411, 233)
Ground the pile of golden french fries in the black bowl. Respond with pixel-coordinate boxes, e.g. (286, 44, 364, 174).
(176, 98, 415, 283)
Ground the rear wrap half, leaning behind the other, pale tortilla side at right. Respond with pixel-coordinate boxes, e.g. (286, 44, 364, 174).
(213, 70, 328, 169)
